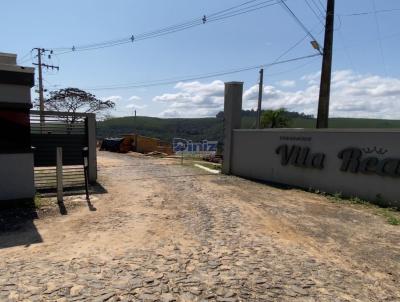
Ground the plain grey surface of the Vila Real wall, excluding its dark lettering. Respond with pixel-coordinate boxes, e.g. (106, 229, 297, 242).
(231, 129, 400, 206)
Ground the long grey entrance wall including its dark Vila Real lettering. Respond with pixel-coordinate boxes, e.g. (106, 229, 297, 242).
(231, 129, 400, 206)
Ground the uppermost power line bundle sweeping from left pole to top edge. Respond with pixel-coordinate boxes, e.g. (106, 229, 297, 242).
(54, 0, 282, 55)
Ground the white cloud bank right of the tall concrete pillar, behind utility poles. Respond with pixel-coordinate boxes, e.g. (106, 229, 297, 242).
(243, 70, 400, 119)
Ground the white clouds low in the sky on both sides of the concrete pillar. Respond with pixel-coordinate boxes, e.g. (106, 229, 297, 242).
(153, 70, 400, 119)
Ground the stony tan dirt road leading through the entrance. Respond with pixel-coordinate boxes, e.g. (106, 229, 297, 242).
(0, 152, 400, 302)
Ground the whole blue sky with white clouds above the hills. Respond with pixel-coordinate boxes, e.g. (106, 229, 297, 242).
(0, 0, 400, 119)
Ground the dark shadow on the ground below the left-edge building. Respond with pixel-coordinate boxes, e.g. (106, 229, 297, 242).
(0, 199, 43, 249)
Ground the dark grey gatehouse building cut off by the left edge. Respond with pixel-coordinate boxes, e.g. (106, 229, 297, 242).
(0, 53, 35, 203)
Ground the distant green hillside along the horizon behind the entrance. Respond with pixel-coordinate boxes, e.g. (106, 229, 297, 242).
(97, 116, 400, 142)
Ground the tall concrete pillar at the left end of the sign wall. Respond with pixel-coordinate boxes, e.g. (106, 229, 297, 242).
(222, 82, 243, 174)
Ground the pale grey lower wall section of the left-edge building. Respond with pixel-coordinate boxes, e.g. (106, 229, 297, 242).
(0, 153, 35, 203)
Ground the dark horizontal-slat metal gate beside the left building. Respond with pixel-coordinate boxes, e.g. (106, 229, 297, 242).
(30, 111, 89, 189)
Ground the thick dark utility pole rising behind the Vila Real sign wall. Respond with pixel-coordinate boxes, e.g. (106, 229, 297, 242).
(317, 0, 335, 128)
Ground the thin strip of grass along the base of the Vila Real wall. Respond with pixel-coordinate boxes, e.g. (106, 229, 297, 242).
(322, 191, 400, 225)
